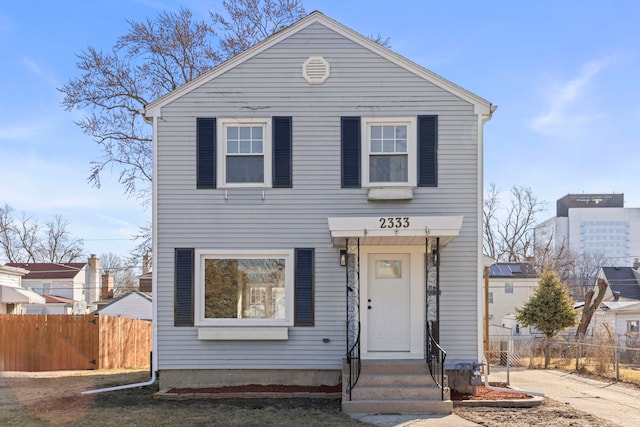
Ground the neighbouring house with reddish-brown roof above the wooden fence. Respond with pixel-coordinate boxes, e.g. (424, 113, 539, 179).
(6, 255, 100, 314)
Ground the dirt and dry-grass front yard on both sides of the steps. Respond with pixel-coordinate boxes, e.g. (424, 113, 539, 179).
(0, 371, 614, 427)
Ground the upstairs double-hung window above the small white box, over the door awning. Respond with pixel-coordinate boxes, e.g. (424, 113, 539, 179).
(362, 118, 417, 187)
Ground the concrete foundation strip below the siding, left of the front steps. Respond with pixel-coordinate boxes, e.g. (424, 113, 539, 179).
(159, 369, 341, 390)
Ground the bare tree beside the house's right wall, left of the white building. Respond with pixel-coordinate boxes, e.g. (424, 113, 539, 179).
(483, 184, 544, 262)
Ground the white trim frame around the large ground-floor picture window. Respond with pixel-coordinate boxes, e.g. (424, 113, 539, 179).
(194, 249, 294, 327)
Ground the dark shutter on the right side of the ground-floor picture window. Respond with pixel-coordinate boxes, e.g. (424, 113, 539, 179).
(294, 248, 315, 326)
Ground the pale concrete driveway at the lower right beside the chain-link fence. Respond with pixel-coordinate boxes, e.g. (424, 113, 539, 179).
(510, 369, 640, 427)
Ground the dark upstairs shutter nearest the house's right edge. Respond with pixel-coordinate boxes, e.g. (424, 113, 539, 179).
(418, 116, 438, 187)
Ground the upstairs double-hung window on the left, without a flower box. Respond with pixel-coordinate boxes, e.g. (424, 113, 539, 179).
(218, 119, 271, 187)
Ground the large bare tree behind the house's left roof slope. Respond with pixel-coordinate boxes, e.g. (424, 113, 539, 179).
(59, 0, 304, 203)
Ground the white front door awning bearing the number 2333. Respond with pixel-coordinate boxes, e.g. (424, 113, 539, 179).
(328, 216, 463, 247)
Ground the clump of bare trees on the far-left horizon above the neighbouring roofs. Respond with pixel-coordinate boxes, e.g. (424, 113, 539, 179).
(0, 204, 83, 262)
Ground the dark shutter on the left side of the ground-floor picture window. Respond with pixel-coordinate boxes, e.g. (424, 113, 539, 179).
(173, 248, 194, 326)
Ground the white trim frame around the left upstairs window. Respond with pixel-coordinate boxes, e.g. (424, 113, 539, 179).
(216, 118, 273, 188)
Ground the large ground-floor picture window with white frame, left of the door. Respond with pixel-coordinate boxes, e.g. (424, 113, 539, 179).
(196, 252, 294, 326)
